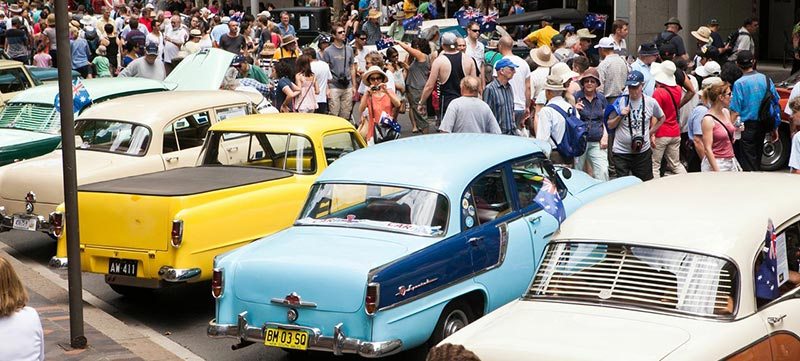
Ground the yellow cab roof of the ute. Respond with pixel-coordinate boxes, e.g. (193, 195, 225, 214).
(209, 113, 355, 134)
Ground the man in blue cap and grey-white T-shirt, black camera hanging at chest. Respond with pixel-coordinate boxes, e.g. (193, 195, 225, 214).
(608, 70, 664, 181)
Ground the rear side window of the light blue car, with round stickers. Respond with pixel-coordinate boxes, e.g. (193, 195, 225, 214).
(461, 168, 511, 228)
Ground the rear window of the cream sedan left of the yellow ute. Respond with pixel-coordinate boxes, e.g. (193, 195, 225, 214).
(75, 119, 152, 156)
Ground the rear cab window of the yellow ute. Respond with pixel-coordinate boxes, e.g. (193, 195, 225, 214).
(199, 131, 317, 174)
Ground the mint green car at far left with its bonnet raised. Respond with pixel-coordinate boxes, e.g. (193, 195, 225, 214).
(0, 49, 238, 166)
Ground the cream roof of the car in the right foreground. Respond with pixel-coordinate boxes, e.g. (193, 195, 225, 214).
(553, 172, 800, 266)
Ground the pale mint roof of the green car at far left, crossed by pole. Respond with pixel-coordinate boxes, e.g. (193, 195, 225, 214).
(10, 78, 168, 105)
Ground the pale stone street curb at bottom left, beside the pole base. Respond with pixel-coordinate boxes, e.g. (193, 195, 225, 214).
(0, 243, 203, 361)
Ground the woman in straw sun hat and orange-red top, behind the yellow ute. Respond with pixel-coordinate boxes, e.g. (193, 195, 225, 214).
(358, 66, 400, 144)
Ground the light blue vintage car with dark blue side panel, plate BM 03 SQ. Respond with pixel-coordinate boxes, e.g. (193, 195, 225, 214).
(207, 134, 639, 357)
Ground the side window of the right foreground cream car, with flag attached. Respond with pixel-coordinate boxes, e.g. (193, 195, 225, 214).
(753, 222, 800, 308)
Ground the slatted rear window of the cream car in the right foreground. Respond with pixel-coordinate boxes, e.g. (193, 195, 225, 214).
(525, 242, 739, 318)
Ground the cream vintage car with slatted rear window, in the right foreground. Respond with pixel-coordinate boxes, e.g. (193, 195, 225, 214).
(442, 173, 800, 361)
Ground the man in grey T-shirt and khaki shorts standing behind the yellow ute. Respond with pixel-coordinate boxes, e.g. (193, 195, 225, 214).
(322, 26, 357, 119)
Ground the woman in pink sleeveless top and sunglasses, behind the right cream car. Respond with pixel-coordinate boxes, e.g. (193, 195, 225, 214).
(700, 83, 739, 172)
